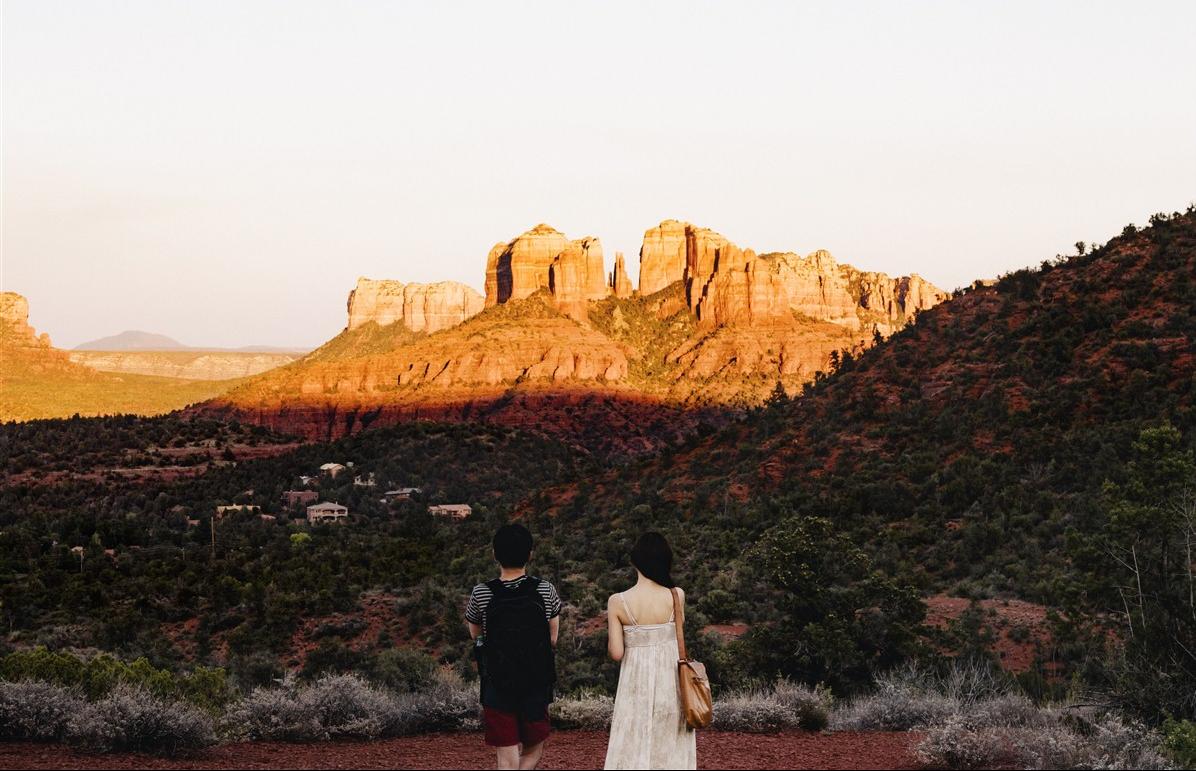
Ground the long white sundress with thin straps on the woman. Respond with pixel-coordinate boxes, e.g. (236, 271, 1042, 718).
(604, 594, 697, 769)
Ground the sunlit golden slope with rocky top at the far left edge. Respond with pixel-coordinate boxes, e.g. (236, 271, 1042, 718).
(0, 292, 233, 421)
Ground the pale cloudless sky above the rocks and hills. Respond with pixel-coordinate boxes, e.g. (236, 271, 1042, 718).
(0, 0, 1196, 348)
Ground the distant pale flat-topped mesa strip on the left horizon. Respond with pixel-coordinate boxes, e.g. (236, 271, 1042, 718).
(69, 350, 299, 380)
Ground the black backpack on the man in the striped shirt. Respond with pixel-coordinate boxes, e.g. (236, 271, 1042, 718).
(482, 576, 556, 700)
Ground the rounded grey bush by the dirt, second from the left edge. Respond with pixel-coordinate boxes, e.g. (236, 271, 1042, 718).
(66, 685, 215, 754)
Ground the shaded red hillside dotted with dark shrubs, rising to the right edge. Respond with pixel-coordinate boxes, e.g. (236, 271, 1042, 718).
(571, 209, 1196, 607)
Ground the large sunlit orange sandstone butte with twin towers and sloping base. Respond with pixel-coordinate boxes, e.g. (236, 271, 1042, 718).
(202, 220, 946, 446)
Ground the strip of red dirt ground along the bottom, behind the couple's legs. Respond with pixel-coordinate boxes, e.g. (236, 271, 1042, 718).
(0, 730, 920, 769)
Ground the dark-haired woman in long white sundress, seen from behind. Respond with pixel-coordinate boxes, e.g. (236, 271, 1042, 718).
(605, 533, 697, 769)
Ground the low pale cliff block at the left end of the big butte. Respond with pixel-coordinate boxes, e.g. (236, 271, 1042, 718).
(348, 279, 483, 334)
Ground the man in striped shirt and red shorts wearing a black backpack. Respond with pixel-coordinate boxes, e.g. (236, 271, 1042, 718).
(465, 525, 561, 769)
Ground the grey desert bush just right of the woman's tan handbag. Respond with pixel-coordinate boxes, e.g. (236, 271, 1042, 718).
(714, 680, 831, 733)
